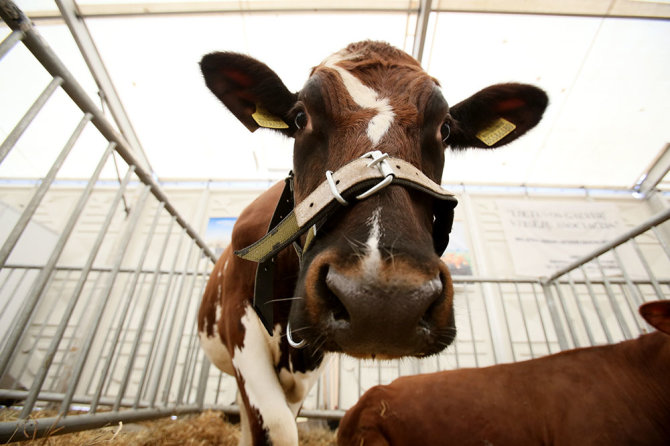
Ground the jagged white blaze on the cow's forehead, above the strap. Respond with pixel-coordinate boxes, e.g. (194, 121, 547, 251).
(323, 52, 395, 147)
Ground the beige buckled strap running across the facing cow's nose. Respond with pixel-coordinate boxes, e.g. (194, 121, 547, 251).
(235, 157, 457, 263)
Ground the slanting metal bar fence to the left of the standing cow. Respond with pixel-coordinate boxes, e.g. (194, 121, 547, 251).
(0, 0, 216, 442)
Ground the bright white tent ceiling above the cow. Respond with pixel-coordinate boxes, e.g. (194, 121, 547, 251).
(0, 0, 670, 188)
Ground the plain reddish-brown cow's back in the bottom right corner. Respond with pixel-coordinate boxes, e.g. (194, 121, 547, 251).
(338, 300, 670, 446)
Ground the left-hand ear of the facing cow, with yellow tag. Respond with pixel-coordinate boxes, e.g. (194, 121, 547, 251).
(200, 52, 297, 134)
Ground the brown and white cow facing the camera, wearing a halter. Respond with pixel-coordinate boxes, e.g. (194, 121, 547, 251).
(198, 41, 547, 445)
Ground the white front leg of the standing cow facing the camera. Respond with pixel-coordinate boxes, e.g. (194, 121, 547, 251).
(233, 306, 298, 446)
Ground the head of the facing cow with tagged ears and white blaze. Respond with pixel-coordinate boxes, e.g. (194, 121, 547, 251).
(201, 42, 547, 358)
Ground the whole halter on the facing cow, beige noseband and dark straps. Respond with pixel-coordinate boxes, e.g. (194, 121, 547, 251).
(235, 150, 458, 335)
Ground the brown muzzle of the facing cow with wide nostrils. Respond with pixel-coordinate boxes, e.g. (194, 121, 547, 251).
(291, 251, 456, 358)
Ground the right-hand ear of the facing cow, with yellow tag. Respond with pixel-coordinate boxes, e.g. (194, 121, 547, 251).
(447, 84, 549, 149)
